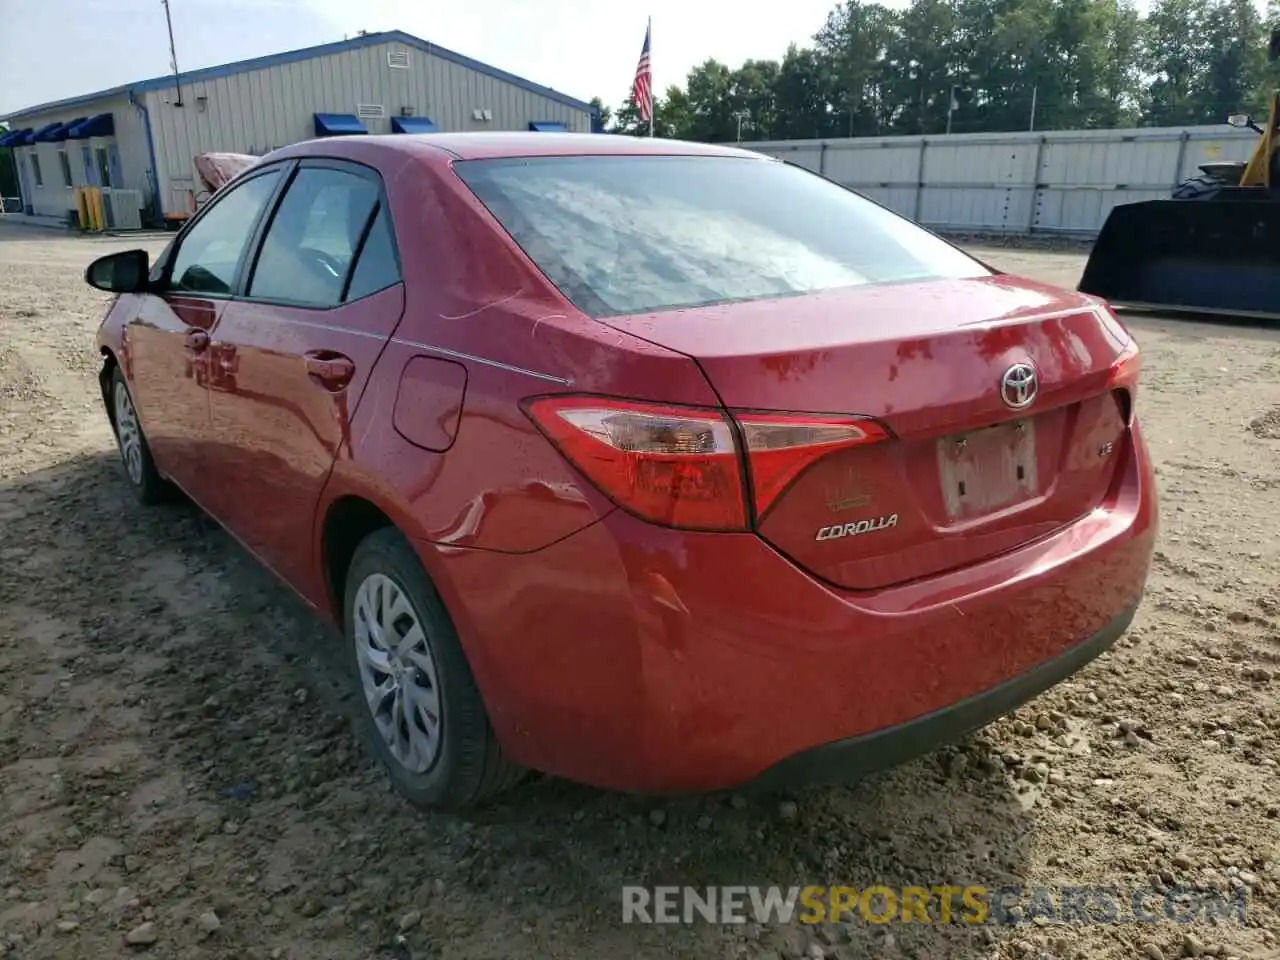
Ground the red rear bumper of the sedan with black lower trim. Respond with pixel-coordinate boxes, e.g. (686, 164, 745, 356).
(420, 428, 1156, 791)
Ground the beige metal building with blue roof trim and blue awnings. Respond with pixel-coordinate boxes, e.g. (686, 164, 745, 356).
(0, 31, 595, 228)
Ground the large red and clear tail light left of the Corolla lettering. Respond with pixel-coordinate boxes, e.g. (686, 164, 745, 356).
(525, 396, 888, 531)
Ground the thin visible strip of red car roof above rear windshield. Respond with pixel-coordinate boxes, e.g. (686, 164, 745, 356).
(280, 131, 769, 160)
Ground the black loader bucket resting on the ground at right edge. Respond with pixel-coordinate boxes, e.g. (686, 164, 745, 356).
(1079, 197, 1280, 319)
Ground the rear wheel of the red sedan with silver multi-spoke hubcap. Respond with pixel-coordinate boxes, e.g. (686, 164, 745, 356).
(343, 527, 522, 810)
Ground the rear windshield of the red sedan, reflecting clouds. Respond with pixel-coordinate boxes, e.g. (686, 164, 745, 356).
(454, 156, 989, 316)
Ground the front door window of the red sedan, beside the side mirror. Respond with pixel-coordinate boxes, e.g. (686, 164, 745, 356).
(169, 170, 280, 294)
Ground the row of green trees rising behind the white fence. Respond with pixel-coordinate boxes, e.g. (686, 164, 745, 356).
(609, 0, 1280, 142)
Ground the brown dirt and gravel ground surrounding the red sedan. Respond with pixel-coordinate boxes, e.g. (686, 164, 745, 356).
(0, 225, 1280, 960)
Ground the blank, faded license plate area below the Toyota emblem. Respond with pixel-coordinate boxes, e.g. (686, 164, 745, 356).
(938, 420, 1039, 520)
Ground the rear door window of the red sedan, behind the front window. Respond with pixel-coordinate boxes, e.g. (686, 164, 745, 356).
(248, 168, 378, 307)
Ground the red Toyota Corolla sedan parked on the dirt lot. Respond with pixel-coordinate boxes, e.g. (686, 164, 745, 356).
(86, 133, 1156, 808)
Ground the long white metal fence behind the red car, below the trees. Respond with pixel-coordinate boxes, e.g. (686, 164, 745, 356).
(745, 124, 1257, 236)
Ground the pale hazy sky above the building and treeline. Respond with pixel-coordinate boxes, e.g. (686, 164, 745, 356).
(0, 0, 860, 115)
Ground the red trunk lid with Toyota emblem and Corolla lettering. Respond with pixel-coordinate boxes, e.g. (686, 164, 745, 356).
(602, 275, 1132, 589)
